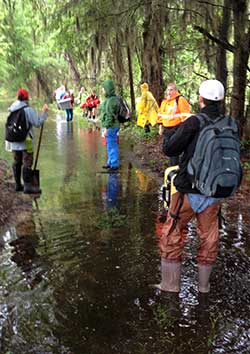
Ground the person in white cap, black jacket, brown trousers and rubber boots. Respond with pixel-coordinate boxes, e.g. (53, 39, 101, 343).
(156, 80, 224, 293)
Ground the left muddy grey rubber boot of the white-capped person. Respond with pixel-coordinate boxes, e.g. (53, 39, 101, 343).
(154, 258, 181, 293)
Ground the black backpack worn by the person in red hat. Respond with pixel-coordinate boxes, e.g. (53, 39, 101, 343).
(5, 106, 30, 143)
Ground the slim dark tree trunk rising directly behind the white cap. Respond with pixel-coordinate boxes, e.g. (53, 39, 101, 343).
(216, 0, 231, 113)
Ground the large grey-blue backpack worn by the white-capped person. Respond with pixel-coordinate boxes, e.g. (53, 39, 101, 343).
(187, 113, 242, 198)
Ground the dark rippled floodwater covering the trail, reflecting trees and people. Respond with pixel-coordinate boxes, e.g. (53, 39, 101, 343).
(0, 111, 250, 354)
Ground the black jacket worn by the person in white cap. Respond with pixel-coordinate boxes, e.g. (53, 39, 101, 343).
(163, 105, 220, 194)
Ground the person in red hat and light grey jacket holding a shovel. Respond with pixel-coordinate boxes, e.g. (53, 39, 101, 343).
(8, 88, 48, 194)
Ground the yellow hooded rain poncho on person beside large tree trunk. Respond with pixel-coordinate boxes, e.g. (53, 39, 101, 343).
(137, 83, 159, 128)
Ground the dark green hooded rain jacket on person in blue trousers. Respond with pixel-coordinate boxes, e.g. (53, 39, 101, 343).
(100, 80, 120, 129)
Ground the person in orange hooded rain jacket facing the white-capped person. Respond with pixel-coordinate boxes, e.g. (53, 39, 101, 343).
(157, 83, 190, 166)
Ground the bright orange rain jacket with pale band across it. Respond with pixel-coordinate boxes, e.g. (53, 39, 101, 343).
(157, 92, 191, 128)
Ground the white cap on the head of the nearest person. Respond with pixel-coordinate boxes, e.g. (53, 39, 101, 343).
(199, 80, 225, 101)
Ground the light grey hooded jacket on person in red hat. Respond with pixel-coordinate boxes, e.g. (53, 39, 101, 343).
(8, 100, 48, 150)
